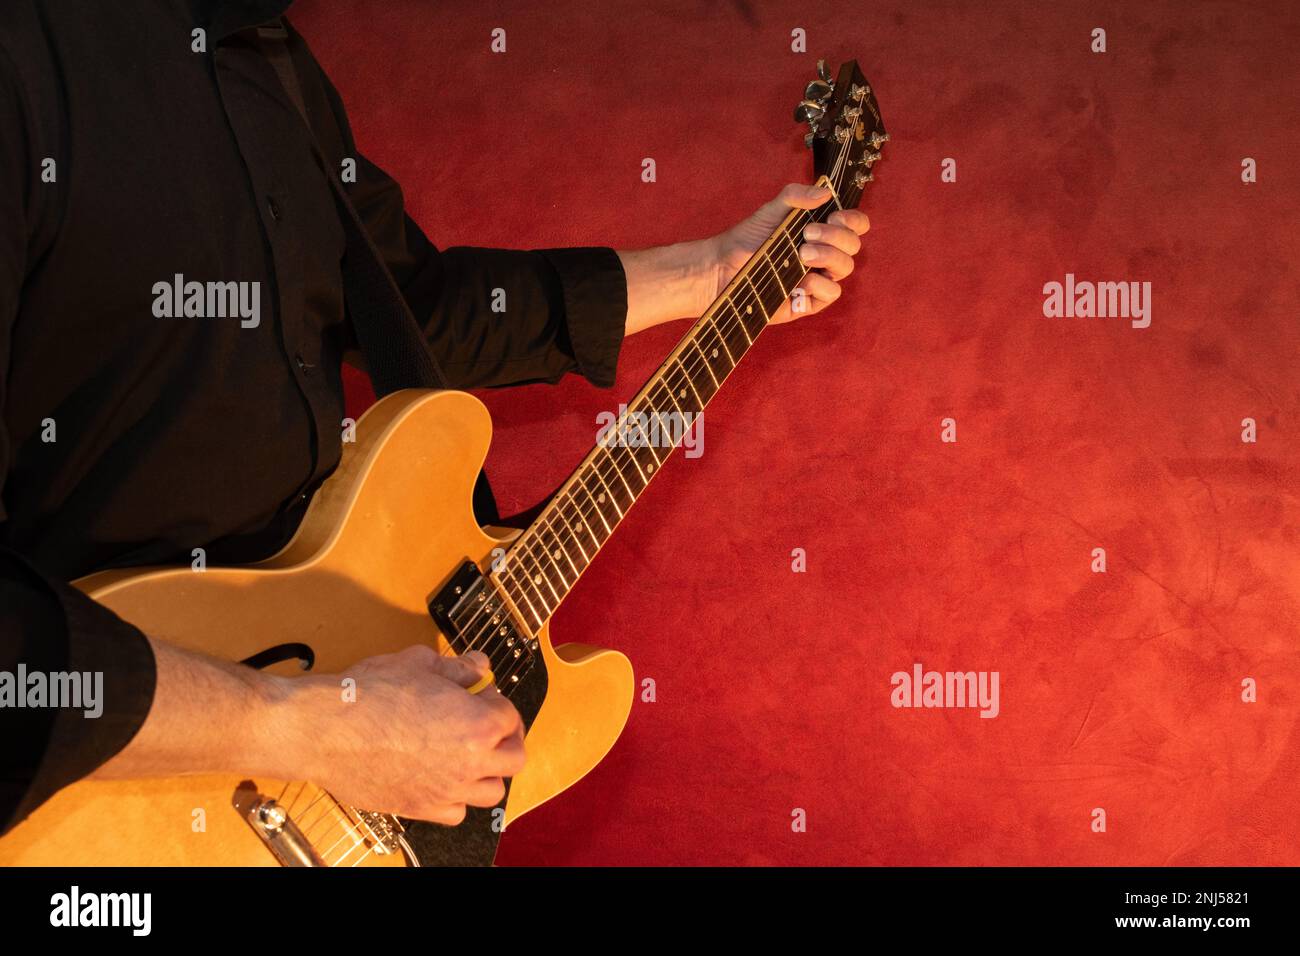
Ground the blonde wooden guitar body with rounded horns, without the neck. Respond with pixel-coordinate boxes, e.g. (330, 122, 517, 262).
(0, 390, 633, 866)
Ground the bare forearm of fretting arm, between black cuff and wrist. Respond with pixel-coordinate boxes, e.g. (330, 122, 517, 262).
(618, 238, 718, 336)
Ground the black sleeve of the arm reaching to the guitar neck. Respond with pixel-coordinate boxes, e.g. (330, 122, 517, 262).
(290, 30, 628, 388)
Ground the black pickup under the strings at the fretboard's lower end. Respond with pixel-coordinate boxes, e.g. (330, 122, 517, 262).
(429, 561, 541, 696)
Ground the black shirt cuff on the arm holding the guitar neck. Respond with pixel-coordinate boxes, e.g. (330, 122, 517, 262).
(537, 246, 628, 389)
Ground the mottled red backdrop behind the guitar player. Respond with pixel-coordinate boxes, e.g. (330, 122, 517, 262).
(291, 0, 1300, 865)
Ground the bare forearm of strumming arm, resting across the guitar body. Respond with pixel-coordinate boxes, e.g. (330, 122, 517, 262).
(91, 639, 300, 779)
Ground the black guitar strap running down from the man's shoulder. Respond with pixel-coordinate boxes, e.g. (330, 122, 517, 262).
(257, 18, 501, 524)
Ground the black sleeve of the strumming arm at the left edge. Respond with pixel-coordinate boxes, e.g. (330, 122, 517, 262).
(0, 39, 155, 832)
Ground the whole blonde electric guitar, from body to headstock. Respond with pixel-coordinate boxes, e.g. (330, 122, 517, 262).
(0, 61, 889, 866)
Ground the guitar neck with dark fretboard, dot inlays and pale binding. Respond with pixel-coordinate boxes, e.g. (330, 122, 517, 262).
(491, 177, 841, 633)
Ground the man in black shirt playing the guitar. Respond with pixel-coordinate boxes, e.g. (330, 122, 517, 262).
(0, 0, 867, 827)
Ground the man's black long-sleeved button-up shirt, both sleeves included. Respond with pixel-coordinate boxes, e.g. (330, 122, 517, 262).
(0, 0, 627, 827)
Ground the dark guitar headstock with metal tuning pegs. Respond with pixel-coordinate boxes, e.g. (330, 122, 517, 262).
(794, 60, 889, 207)
